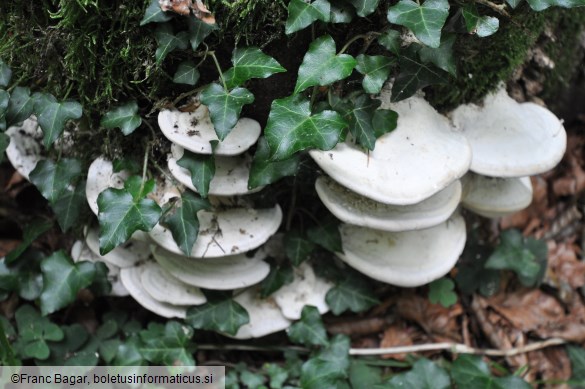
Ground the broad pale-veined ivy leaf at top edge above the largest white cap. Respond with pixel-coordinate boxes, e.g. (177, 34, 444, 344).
(388, 0, 449, 47)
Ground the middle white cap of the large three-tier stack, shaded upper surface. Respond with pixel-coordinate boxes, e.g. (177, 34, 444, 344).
(315, 177, 461, 231)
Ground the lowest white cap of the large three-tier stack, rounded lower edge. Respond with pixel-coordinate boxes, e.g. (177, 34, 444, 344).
(336, 214, 466, 287)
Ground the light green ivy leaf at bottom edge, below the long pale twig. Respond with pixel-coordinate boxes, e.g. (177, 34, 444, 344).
(376, 358, 452, 389)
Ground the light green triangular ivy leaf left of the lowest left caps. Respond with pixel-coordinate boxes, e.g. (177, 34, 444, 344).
(41, 251, 95, 315)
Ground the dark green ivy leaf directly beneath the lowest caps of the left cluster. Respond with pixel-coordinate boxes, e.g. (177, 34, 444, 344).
(185, 296, 250, 335)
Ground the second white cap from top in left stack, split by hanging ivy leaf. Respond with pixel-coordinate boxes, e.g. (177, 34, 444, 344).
(167, 143, 263, 196)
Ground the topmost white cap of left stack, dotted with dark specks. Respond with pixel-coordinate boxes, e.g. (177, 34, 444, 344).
(158, 104, 260, 155)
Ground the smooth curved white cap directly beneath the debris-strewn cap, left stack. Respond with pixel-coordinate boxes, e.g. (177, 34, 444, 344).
(152, 247, 270, 290)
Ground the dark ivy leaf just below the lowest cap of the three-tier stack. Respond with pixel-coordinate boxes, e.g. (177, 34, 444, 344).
(325, 273, 380, 315)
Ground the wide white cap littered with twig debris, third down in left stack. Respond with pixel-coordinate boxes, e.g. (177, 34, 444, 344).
(149, 204, 282, 258)
